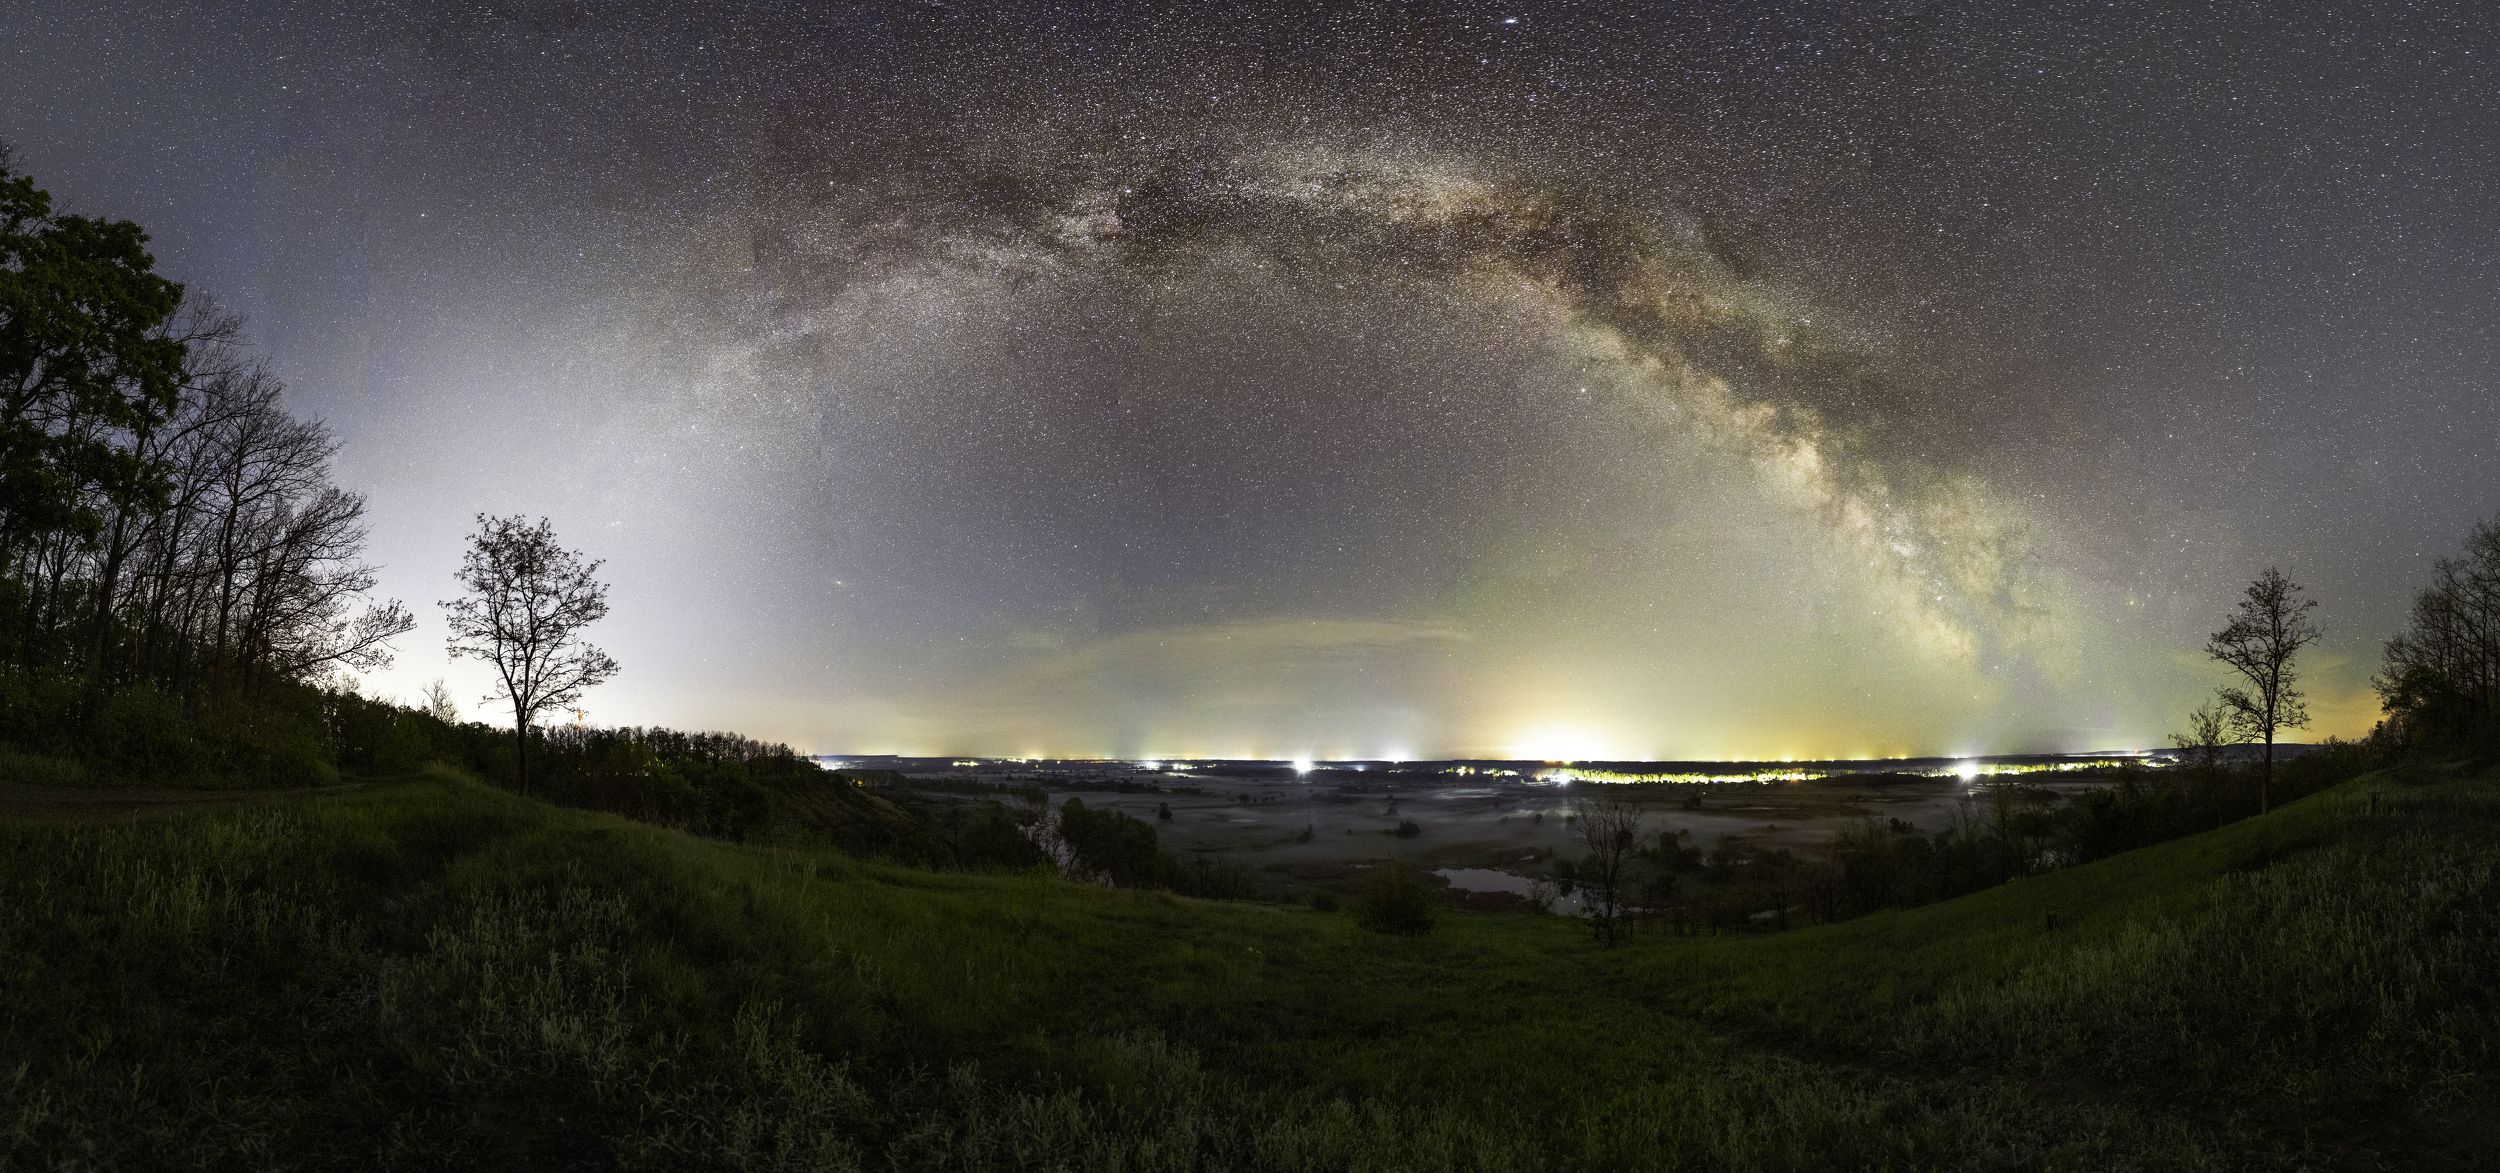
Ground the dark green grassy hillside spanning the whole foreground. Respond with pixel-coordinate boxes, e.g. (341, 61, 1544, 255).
(0, 755, 2500, 1170)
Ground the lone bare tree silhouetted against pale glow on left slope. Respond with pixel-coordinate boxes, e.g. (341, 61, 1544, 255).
(443, 513, 618, 793)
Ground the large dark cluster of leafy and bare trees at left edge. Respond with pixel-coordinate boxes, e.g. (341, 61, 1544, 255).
(0, 153, 410, 780)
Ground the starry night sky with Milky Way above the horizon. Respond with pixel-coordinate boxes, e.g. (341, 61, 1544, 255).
(0, 0, 2500, 758)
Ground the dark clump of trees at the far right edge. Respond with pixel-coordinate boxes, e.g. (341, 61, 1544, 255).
(2370, 518, 2500, 753)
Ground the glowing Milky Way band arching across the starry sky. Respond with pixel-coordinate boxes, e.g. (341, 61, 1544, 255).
(758, 148, 2063, 670)
